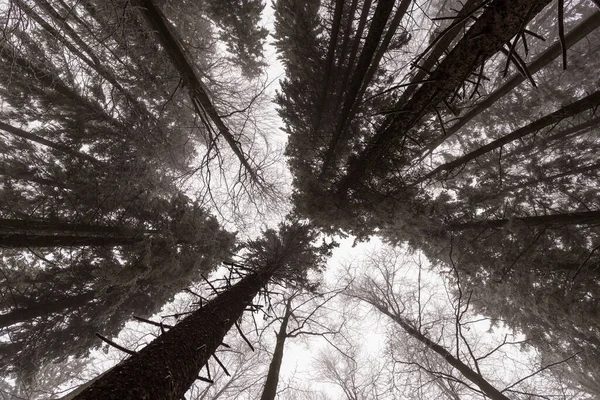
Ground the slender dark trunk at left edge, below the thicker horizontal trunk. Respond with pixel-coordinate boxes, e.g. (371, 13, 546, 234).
(0, 292, 96, 329)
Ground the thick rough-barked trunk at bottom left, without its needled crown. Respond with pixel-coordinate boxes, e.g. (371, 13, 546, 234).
(75, 268, 275, 400)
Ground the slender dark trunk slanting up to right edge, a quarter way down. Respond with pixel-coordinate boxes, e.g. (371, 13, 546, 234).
(413, 92, 600, 185)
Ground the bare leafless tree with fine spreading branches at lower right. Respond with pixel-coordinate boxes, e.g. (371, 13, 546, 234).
(349, 249, 588, 399)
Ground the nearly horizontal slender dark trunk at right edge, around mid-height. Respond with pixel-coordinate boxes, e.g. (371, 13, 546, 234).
(446, 211, 600, 232)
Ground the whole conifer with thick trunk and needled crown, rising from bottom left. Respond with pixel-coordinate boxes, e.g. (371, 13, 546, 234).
(76, 224, 331, 399)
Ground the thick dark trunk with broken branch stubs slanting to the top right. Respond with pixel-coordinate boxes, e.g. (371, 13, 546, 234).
(336, 0, 550, 196)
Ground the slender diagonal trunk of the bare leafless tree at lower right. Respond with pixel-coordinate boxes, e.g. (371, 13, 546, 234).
(369, 302, 510, 400)
